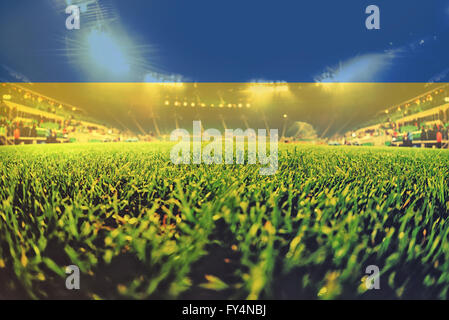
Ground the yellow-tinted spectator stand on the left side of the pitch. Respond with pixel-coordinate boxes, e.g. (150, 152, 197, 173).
(0, 83, 124, 145)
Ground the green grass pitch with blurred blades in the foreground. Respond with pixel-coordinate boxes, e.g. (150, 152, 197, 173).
(0, 143, 449, 299)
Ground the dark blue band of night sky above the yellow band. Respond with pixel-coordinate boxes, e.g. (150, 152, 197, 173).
(0, 0, 449, 82)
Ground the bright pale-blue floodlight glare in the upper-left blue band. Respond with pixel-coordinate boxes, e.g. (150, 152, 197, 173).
(87, 30, 130, 74)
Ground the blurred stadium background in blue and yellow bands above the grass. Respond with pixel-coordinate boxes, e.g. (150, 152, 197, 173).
(0, 0, 449, 145)
